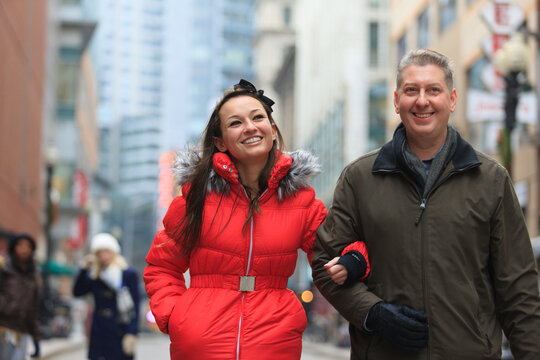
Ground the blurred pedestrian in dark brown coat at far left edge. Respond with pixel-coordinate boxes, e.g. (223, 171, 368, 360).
(0, 234, 41, 360)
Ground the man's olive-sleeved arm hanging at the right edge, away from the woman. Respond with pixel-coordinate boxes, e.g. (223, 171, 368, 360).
(490, 174, 540, 360)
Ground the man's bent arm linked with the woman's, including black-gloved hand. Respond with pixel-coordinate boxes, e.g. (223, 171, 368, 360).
(313, 168, 429, 353)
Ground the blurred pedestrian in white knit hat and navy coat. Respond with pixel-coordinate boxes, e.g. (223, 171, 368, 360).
(73, 233, 139, 360)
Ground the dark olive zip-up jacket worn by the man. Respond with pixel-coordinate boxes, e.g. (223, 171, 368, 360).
(313, 129, 540, 360)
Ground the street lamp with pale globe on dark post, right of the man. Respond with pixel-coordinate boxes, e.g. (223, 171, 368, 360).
(495, 33, 527, 174)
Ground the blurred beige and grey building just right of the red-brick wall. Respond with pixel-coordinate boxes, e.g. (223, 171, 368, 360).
(47, 1, 99, 264)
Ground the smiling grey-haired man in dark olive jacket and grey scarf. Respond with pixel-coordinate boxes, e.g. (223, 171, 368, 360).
(313, 50, 540, 360)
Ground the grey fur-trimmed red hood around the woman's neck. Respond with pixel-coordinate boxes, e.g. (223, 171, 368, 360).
(172, 150, 321, 201)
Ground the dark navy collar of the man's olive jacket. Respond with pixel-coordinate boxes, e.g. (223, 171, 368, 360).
(371, 123, 482, 173)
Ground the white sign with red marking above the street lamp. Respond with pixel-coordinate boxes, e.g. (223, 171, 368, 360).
(481, 0, 525, 35)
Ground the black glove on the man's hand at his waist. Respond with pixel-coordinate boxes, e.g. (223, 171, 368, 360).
(366, 302, 429, 353)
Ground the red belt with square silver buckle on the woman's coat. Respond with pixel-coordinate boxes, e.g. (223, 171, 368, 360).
(190, 274, 289, 291)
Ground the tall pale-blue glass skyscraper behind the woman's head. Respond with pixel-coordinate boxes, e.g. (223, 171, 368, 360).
(84, 0, 255, 271)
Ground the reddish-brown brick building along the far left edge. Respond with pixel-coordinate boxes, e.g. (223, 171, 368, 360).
(0, 1, 48, 255)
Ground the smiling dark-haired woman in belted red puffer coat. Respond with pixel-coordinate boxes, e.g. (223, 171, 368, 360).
(144, 80, 368, 360)
